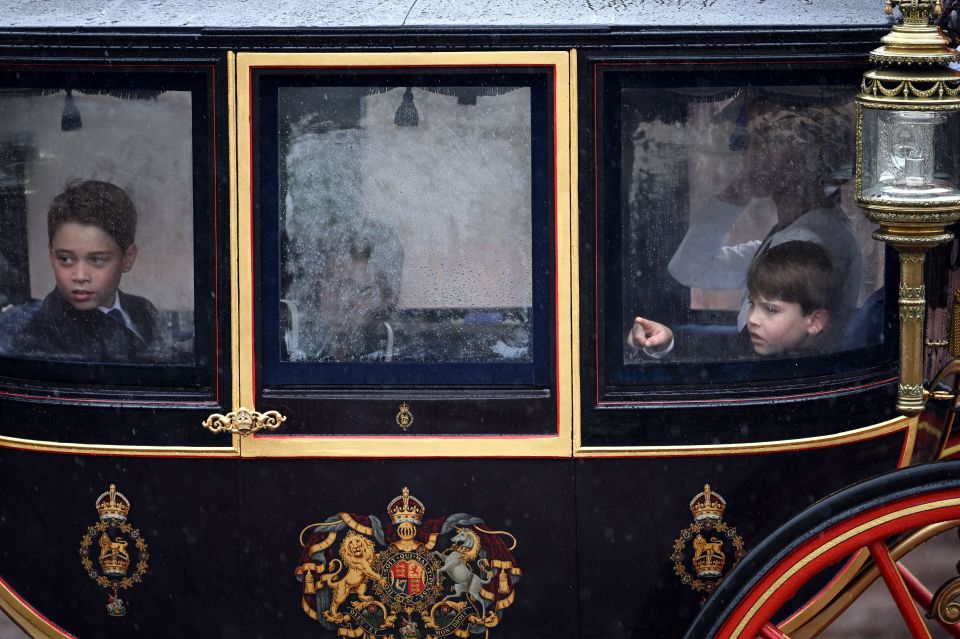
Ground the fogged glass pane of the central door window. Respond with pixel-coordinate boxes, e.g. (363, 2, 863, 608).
(277, 86, 533, 364)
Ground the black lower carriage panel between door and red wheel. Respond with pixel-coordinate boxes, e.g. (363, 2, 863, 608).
(576, 429, 906, 638)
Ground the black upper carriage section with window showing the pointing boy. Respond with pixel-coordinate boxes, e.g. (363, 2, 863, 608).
(580, 59, 897, 447)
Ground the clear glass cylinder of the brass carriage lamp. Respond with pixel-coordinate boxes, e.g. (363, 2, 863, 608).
(860, 108, 960, 204)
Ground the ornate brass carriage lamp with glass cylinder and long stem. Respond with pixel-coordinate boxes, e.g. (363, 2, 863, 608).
(856, 0, 960, 415)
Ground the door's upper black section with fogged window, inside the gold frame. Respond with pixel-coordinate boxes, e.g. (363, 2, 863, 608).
(239, 53, 569, 450)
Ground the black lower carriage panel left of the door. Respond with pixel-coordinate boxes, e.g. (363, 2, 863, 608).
(0, 447, 244, 637)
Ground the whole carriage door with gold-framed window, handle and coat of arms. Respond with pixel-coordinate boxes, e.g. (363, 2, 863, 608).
(226, 52, 576, 636)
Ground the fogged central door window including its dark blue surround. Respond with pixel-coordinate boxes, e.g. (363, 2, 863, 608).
(258, 70, 554, 385)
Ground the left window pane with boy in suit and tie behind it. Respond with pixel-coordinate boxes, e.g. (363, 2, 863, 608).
(0, 87, 194, 364)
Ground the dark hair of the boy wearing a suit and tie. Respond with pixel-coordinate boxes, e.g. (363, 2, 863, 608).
(47, 180, 137, 251)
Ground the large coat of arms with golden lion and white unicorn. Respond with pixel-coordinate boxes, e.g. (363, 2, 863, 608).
(296, 488, 521, 639)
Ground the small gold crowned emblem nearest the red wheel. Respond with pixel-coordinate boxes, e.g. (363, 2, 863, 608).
(670, 484, 746, 593)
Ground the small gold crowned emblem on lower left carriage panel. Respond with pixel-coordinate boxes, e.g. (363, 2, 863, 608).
(80, 484, 150, 617)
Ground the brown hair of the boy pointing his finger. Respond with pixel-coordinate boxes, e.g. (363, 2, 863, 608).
(747, 240, 840, 315)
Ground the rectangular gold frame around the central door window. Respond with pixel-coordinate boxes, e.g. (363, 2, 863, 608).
(231, 51, 578, 458)
